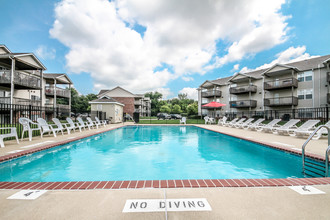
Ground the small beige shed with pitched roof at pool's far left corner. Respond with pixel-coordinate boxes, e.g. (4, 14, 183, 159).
(89, 96, 125, 123)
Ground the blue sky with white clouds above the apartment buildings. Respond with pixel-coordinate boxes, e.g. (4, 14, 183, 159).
(0, 0, 330, 99)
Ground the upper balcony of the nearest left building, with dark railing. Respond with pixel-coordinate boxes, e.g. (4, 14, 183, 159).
(0, 70, 41, 90)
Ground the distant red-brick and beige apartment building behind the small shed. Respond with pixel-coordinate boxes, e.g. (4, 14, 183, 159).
(98, 86, 151, 116)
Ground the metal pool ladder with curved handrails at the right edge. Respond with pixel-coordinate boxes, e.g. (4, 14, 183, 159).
(301, 125, 330, 177)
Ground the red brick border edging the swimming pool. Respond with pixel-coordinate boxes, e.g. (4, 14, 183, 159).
(0, 125, 330, 190)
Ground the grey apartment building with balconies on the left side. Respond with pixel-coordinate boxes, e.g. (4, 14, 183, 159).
(0, 45, 72, 121)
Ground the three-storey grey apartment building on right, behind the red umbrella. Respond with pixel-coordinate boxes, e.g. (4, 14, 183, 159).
(198, 55, 330, 117)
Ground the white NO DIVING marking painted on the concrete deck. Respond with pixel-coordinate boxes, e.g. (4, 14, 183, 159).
(123, 198, 212, 213)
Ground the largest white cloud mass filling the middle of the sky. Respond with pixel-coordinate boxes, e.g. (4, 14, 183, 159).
(50, 0, 287, 93)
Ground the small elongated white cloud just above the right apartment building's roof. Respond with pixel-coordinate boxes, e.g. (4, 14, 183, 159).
(240, 46, 317, 73)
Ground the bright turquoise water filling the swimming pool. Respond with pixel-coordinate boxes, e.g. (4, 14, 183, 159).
(0, 126, 303, 182)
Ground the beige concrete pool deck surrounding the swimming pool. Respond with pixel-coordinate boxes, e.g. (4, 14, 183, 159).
(0, 123, 330, 219)
